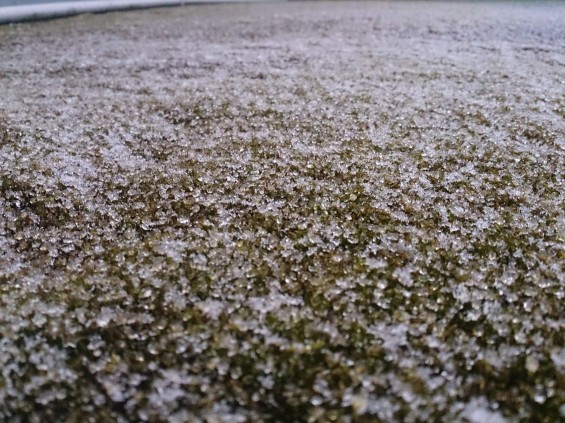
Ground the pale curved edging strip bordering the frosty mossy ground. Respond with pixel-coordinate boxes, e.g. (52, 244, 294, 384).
(0, 0, 285, 24)
